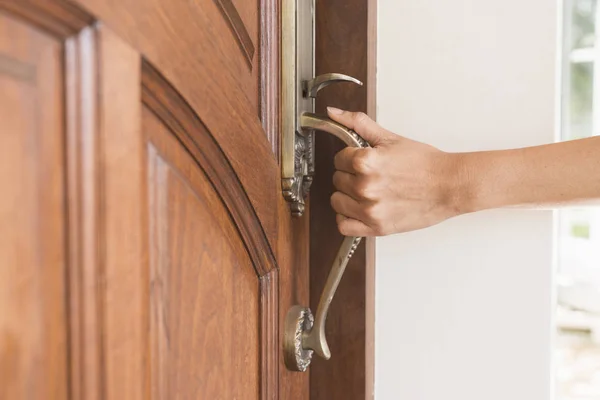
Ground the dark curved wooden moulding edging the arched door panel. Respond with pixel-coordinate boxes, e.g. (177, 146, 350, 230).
(142, 63, 289, 399)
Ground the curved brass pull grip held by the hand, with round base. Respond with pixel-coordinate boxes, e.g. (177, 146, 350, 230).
(283, 113, 369, 371)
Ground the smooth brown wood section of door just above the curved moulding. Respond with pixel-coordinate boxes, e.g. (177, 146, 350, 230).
(69, 0, 281, 231)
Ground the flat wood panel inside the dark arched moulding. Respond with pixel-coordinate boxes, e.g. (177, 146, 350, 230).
(143, 109, 262, 400)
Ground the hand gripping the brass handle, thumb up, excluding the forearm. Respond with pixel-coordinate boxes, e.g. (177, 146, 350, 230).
(328, 107, 461, 236)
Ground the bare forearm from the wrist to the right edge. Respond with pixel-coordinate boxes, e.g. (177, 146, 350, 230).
(457, 137, 600, 212)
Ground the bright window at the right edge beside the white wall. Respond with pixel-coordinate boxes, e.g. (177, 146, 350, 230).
(555, 0, 600, 400)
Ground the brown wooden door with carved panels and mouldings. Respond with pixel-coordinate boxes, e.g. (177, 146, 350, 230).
(0, 0, 376, 400)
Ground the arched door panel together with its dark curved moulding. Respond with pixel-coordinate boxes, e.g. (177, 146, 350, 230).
(142, 63, 278, 399)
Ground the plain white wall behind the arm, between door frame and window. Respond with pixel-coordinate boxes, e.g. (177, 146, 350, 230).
(375, 0, 558, 400)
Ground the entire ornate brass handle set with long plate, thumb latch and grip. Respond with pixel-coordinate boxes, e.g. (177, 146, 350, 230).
(281, 0, 368, 371)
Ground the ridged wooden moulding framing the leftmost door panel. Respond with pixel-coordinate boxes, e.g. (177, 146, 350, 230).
(0, 7, 102, 399)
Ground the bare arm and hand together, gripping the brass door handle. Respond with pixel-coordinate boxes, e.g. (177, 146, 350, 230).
(329, 109, 600, 236)
